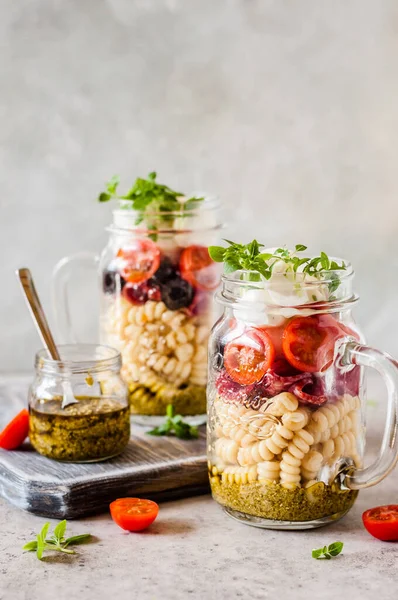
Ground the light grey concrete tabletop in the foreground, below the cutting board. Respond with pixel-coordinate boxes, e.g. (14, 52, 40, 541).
(0, 452, 398, 600)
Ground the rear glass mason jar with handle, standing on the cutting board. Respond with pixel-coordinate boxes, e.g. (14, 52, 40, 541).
(54, 198, 221, 423)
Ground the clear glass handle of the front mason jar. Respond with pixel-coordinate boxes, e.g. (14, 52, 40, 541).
(337, 341, 398, 490)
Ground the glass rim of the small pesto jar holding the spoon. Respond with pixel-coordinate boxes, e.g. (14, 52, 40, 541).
(35, 344, 122, 375)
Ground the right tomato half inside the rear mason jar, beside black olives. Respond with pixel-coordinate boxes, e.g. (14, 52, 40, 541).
(180, 246, 220, 290)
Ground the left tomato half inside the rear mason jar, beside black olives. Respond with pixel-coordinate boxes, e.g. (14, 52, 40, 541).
(117, 240, 160, 283)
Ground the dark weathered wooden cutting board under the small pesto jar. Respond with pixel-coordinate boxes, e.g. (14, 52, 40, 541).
(0, 379, 209, 519)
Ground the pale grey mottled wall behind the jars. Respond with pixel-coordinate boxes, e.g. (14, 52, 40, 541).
(0, 0, 398, 372)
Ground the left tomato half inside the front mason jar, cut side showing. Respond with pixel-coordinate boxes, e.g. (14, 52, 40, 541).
(224, 329, 275, 385)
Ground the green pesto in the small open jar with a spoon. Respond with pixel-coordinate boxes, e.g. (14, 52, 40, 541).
(29, 397, 130, 462)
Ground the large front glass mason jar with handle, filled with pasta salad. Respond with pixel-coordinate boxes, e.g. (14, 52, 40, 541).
(208, 263, 398, 529)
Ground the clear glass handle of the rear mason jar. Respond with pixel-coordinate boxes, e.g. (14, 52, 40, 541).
(52, 252, 99, 344)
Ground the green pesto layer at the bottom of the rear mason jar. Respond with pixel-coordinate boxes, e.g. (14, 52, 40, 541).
(129, 383, 206, 416)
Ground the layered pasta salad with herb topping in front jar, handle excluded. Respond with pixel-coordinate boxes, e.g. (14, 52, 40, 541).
(208, 241, 363, 522)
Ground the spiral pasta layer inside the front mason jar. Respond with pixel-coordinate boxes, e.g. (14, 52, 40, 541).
(215, 393, 360, 490)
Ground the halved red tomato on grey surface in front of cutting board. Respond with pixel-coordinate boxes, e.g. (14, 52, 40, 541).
(109, 498, 159, 531)
